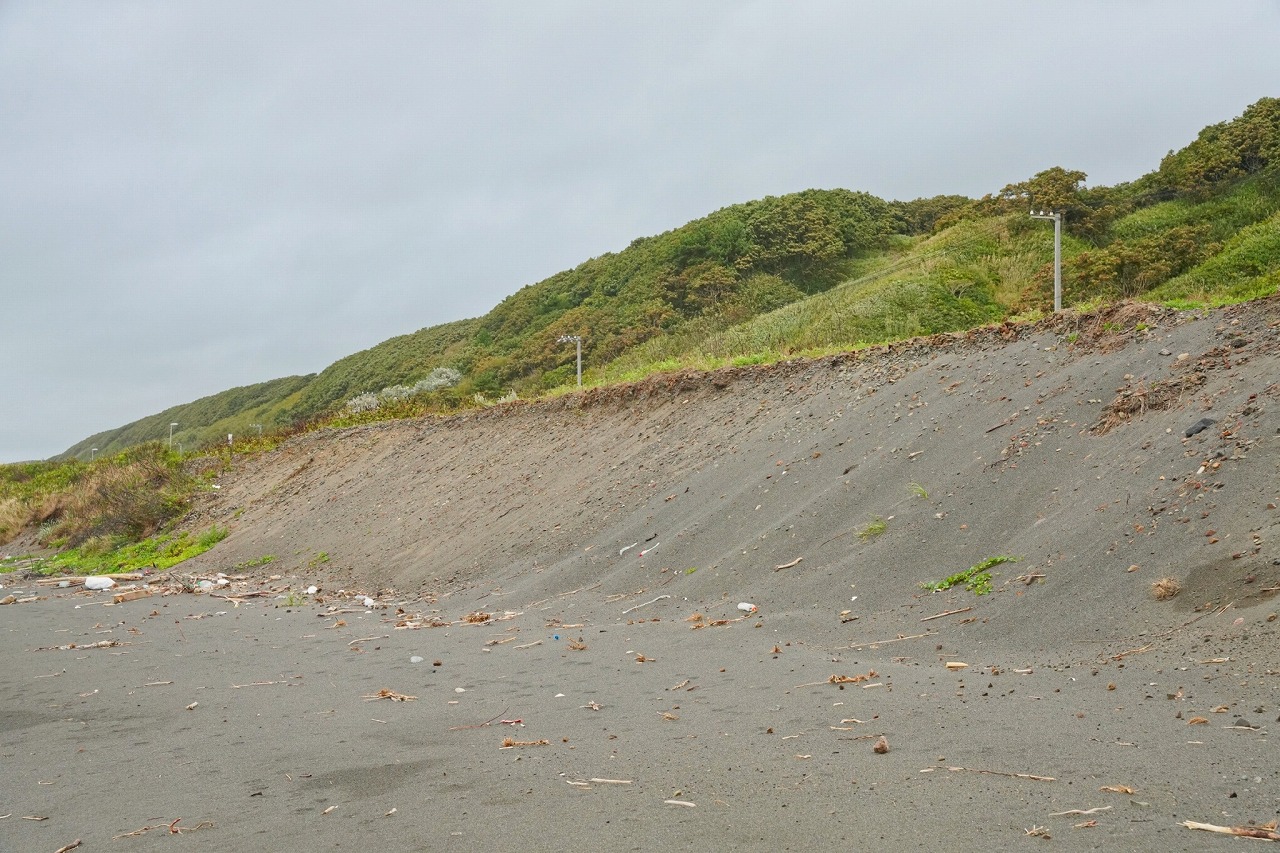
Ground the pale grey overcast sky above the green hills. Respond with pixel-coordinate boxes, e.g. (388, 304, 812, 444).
(0, 0, 1280, 462)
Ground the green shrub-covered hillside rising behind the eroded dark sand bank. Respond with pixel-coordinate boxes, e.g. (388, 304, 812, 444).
(64, 97, 1280, 459)
